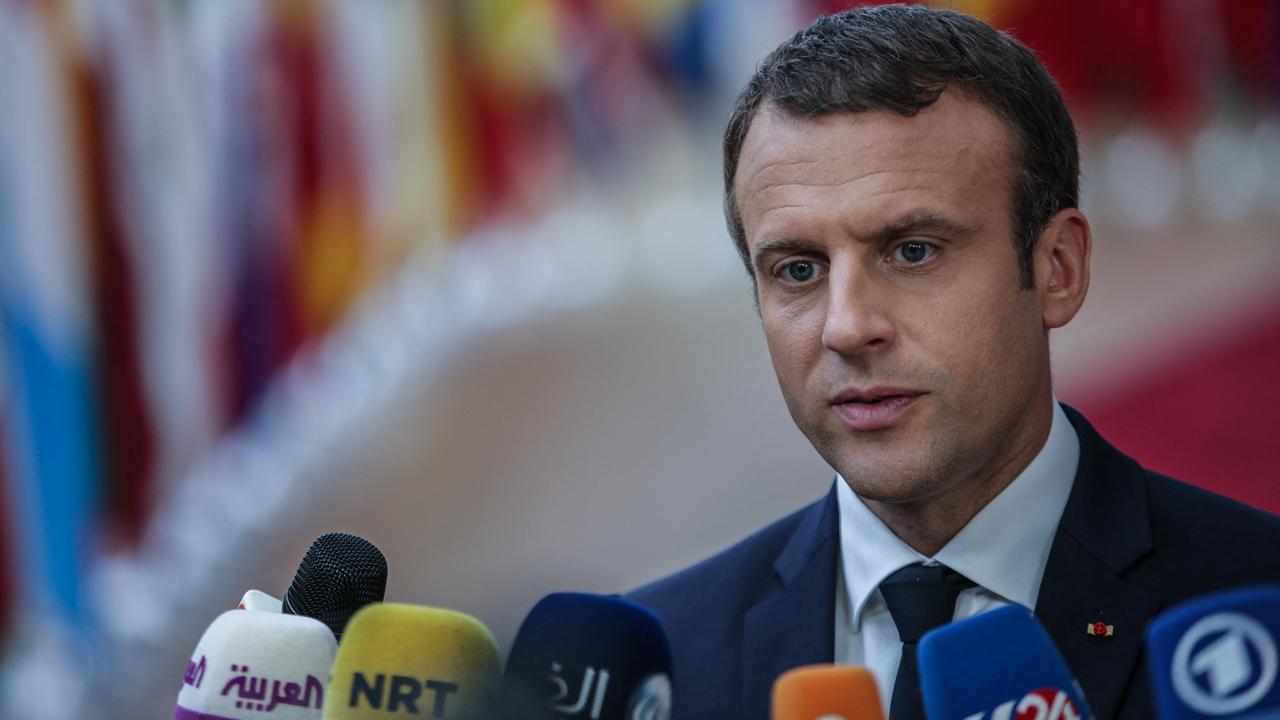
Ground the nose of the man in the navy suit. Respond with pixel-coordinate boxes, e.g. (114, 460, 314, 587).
(822, 266, 895, 356)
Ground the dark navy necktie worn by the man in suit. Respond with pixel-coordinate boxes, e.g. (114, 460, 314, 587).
(881, 565, 974, 720)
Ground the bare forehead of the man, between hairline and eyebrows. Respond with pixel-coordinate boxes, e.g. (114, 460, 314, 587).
(733, 91, 1015, 245)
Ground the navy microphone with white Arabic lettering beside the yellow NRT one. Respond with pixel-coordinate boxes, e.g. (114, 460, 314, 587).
(503, 593, 672, 720)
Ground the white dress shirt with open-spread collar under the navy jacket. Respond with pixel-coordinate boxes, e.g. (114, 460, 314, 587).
(836, 400, 1080, 711)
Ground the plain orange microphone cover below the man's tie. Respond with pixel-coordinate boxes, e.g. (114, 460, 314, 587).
(773, 665, 884, 720)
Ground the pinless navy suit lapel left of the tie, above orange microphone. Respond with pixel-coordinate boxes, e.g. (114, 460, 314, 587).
(742, 480, 838, 719)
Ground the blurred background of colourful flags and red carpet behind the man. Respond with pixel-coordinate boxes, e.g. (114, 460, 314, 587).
(0, 0, 1280, 720)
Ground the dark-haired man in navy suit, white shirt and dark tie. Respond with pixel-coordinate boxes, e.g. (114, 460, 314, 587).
(632, 6, 1280, 720)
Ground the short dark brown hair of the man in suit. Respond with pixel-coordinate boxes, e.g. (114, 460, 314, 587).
(724, 5, 1080, 288)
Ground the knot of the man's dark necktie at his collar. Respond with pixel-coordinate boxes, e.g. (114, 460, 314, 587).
(881, 565, 974, 643)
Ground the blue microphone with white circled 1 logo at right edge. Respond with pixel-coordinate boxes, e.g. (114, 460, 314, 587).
(1147, 585, 1280, 720)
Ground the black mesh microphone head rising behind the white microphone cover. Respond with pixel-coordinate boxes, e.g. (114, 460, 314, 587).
(280, 533, 387, 638)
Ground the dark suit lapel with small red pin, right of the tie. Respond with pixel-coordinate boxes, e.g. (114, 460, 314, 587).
(1036, 407, 1160, 717)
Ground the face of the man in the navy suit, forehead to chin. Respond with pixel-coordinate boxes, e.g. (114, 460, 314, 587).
(735, 92, 1050, 503)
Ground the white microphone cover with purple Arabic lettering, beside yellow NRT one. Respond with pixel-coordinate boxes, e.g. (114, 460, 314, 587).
(173, 610, 338, 720)
